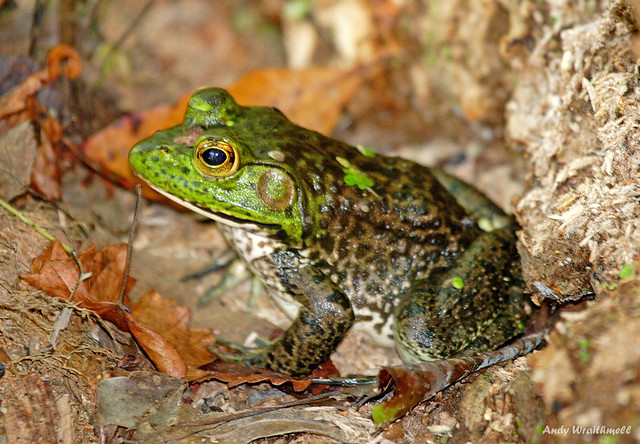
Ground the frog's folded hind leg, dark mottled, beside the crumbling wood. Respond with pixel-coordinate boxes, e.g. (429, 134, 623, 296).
(394, 225, 525, 362)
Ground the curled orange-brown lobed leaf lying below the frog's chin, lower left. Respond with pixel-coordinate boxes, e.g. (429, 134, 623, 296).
(21, 242, 221, 379)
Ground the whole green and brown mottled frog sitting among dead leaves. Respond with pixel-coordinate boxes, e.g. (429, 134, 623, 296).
(129, 88, 525, 377)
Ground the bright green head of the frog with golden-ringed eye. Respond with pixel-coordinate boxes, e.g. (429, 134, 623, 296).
(129, 88, 318, 244)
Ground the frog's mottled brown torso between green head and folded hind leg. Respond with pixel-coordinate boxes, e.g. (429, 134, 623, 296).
(248, 127, 478, 345)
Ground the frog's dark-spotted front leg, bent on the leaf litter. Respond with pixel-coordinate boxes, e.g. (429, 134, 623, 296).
(229, 252, 354, 377)
